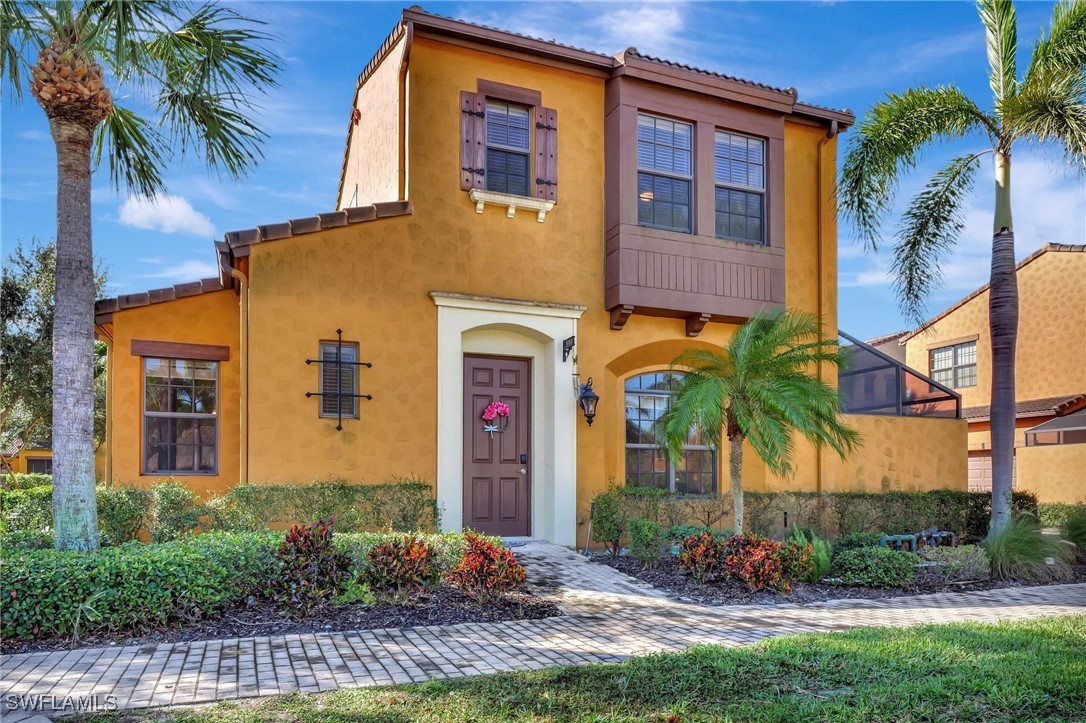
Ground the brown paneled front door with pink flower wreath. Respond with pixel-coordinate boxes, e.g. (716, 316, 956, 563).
(464, 356, 531, 537)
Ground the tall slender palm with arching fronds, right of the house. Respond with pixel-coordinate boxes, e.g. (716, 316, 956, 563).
(837, 0, 1086, 532)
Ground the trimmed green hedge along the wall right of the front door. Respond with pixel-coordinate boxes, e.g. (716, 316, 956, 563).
(593, 487, 1037, 543)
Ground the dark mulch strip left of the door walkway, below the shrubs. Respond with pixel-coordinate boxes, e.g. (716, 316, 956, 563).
(0, 587, 561, 655)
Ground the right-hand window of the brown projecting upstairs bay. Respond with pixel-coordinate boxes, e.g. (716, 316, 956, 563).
(715, 130, 766, 243)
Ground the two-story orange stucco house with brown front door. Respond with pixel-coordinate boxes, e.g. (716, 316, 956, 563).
(89, 9, 965, 545)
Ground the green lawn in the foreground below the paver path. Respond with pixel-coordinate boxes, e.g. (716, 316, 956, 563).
(78, 616, 1086, 723)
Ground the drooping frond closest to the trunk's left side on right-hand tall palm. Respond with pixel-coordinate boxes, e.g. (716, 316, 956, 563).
(892, 154, 981, 324)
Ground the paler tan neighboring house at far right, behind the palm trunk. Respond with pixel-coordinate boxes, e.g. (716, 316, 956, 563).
(901, 243, 1086, 502)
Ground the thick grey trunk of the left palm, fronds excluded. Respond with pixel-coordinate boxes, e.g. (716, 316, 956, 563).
(47, 115, 99, 550)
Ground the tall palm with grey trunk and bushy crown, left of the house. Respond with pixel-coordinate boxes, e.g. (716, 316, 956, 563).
(0, 0, 279, 549)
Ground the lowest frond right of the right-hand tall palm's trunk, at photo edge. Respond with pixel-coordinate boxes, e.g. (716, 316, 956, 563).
(1003, 72, 1086, 173)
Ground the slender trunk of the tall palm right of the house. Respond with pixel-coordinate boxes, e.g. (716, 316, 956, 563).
(988, 150, 1019, 532)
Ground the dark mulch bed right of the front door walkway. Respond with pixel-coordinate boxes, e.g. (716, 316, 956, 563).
(593, 555, 1086, 605)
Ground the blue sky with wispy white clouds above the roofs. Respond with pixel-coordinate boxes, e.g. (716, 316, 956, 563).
(0, 1, 1086, 337)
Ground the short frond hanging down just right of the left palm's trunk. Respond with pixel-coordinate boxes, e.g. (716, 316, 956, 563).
(94, 104, 169, 195)
